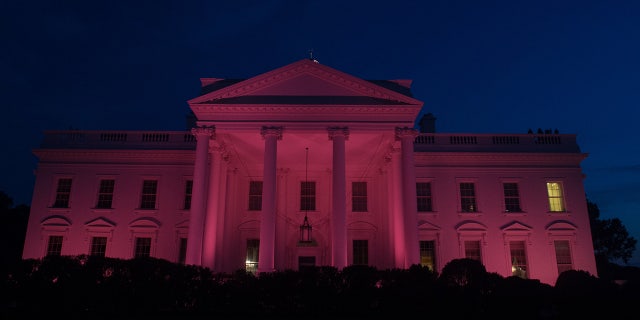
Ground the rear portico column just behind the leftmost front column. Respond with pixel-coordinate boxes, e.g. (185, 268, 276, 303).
(202, 141, 226, 270)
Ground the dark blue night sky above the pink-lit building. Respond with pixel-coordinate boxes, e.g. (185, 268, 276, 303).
(0, 0, 640, 265)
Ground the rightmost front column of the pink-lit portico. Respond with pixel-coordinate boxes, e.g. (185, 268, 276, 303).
(396, 127, 420, 268)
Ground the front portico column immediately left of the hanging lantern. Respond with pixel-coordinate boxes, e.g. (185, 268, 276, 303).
(258, 127, 282, 273)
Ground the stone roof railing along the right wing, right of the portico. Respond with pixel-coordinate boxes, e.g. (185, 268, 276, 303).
(414, 133, 580, 152)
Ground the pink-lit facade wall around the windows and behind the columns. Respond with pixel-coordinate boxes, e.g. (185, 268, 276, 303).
(24, 135, 595, 283)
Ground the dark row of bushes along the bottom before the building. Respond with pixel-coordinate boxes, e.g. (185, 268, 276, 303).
(0, 256, 640, 319)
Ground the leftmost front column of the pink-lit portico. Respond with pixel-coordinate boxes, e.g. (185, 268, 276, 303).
(186, 127, 215, 266)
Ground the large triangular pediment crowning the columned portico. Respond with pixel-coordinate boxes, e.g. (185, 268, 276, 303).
(189, 59, 422, 106)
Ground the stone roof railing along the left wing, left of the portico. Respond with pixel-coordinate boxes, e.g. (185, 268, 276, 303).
(40, 130, 196, 150)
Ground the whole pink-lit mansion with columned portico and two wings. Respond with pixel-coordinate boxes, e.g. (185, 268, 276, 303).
(23, 59, 596, 284)
